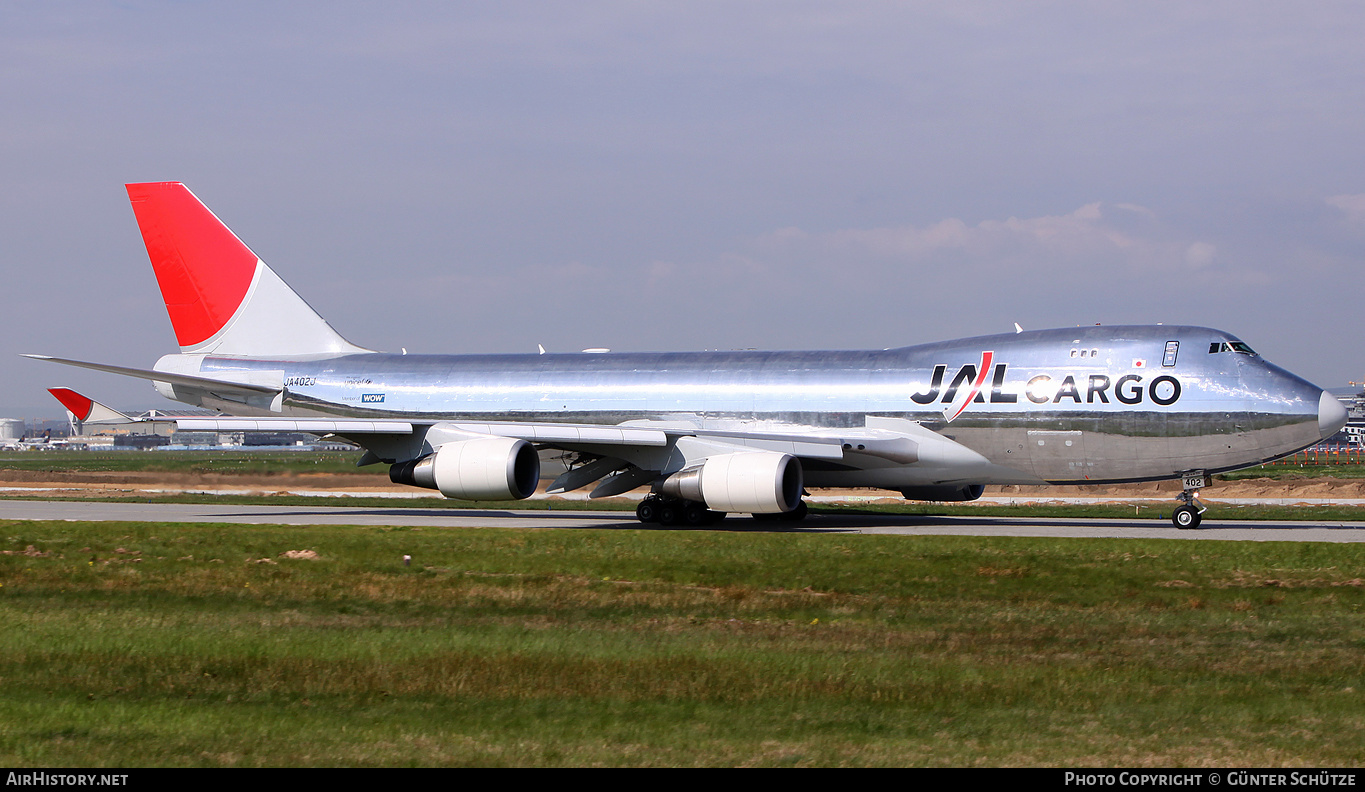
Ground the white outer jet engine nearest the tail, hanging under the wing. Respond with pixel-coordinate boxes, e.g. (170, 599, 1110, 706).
(389, 437, 541, 501)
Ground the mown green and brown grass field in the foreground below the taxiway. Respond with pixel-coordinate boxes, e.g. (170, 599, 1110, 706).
(0, 522, 1365, 766)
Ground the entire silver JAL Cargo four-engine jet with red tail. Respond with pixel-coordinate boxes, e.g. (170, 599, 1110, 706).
(30, 182, 1346, 527)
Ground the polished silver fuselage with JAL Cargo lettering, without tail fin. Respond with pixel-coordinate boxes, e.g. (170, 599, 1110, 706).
(157, 326, 1324, 487)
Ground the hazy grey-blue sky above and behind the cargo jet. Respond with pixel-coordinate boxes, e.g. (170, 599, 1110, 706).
(0, 0, 1365, 418)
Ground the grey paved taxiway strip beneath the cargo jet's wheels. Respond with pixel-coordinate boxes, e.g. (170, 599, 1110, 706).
(0, 500, 1365, 542)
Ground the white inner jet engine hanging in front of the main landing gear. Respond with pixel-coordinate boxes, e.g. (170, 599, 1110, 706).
(662, 451, 804, 513)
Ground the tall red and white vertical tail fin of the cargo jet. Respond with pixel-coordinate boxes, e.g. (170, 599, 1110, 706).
(127, 182, 370, 356)
